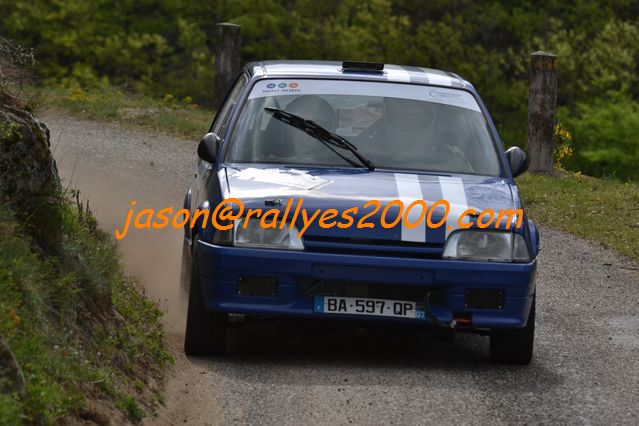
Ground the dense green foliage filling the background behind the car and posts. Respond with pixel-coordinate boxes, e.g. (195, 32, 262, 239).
(0, 0, 639, 178)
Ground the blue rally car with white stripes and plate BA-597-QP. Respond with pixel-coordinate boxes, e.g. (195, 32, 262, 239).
(182, 61, 539, 364)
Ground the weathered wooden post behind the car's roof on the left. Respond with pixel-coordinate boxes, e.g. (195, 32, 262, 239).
(213, 23, 242, 109)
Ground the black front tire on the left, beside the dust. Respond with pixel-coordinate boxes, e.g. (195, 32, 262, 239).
(184, 239, 228, 356)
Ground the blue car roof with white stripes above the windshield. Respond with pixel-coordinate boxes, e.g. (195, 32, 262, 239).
(245, 60, 472, 89)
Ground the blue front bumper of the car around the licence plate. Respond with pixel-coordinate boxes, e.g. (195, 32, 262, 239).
(197, 241, 537, 329)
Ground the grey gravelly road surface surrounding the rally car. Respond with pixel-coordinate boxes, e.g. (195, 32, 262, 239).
(43, 113, 639, 425)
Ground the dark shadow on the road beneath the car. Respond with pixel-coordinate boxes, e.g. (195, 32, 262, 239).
(191, 318, 559, 390)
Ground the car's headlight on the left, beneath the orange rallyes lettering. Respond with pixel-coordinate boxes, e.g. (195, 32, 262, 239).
(233, 218, 304, 250)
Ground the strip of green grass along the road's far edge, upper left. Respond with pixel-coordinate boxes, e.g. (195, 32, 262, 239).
(22, 86, 215, 141)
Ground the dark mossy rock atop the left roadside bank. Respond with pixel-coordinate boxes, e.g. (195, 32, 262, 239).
(0, 105, 61, 249)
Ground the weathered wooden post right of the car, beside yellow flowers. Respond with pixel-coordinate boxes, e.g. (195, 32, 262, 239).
(526, 52, 557, 172)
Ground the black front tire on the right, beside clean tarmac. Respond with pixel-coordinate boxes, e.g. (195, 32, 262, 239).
(490, 296, 535, 365)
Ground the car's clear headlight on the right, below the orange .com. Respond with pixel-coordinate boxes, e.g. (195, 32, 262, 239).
(443, 230, 530, 262)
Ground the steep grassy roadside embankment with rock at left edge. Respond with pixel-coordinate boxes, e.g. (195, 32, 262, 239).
(0, 99, 171, 425)
